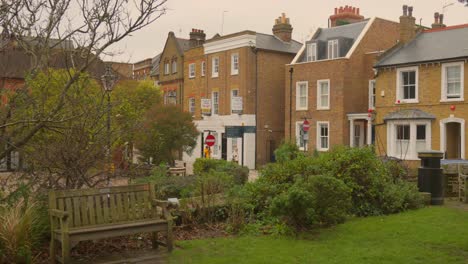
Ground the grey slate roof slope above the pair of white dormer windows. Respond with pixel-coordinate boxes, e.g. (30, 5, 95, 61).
(313, 19, 369, 41)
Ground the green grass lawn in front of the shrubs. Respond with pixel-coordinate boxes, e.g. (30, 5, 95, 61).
(169, 207, 468, 264)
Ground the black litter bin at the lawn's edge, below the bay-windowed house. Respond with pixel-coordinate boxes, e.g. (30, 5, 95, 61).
(418, 151, 445, 205)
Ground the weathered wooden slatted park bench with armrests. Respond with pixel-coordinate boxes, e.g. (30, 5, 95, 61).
(49, 184, 173, 263)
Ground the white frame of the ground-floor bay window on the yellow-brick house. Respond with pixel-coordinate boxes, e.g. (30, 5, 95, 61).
(387, 119, 432, 160)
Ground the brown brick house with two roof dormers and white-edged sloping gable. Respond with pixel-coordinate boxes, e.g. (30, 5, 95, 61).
(284, 6, 399, 152)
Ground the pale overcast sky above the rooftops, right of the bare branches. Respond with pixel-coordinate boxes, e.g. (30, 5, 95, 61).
(107, 0, 468, 62)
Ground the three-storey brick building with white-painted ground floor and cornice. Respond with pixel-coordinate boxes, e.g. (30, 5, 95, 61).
(184, 14, 301, 169)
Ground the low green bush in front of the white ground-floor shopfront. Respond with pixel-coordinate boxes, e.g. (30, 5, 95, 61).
(193, 159, 249, 184)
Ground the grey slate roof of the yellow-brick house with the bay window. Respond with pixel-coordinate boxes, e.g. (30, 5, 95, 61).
(375, 24, 468, 68)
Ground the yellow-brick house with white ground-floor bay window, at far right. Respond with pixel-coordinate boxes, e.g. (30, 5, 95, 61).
(375, 6, 468, 166)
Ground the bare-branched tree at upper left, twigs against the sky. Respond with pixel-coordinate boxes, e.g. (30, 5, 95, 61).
(0, 0, 166, 162)
